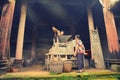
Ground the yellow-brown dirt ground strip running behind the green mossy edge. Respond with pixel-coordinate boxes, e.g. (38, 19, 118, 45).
(0, 65, 120, 79)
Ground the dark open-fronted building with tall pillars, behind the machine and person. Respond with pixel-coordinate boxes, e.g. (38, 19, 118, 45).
(0, 0, 120, 71)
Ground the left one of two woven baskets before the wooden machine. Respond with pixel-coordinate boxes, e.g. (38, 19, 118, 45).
(50, 62, 63, 73)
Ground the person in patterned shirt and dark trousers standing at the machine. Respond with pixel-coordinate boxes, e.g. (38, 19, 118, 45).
(74, 35, 85, 72)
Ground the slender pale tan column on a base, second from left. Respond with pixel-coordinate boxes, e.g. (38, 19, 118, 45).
(14, 0, 27, 67)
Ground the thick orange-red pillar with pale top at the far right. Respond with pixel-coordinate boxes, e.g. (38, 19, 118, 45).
(101, 0, 119, 53)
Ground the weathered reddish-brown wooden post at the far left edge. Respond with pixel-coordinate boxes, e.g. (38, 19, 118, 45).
(0, 0, 15, 59)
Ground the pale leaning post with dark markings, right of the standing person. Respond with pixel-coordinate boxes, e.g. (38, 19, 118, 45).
(87, 3, 105, 68)
